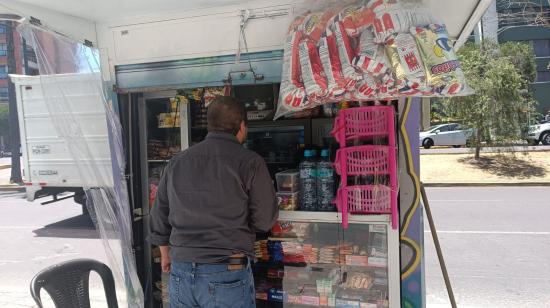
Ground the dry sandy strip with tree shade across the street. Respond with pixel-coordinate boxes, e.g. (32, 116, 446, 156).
(420, 151, 550, 186)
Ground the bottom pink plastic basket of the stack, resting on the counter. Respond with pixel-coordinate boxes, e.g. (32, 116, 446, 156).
(336, 185, 398, 229)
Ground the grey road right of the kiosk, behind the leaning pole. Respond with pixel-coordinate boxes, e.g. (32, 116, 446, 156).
(425, 187, 550, 308)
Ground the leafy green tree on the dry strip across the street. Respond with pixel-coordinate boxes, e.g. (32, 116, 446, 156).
(445, 41, 536, 159)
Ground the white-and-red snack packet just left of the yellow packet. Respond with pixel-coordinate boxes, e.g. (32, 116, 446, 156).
(386, 33, 428, 95)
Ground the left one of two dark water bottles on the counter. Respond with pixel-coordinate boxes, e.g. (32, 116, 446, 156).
(300, 150, 317, 211)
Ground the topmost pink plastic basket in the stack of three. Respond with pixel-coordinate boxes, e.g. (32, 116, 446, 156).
(331, 106, 395, 148)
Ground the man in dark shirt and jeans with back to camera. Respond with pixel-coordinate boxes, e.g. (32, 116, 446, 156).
(149, 97, 278, 308)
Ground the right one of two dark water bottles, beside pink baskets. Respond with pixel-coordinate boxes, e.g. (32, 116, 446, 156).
(317, 149, 335, 212)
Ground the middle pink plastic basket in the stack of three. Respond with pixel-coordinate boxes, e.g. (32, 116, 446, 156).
(334, 145, 397, 178)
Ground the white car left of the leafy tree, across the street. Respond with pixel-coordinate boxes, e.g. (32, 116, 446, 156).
(419, 123, 474, 149)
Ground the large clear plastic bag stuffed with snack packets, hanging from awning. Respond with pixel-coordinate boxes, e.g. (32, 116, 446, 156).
(275, 0, 472, 118)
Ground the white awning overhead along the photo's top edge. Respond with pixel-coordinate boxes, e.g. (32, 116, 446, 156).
(0, 0, 491, 46)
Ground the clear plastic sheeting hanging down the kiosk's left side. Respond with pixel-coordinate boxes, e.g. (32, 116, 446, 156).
(19, 23, 143, 307)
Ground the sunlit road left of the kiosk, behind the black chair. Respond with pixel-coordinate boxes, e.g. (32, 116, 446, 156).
(0, 192, 125, 308)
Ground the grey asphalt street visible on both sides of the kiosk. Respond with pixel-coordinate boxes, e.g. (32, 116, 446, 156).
(0, 187, 550, 308)
